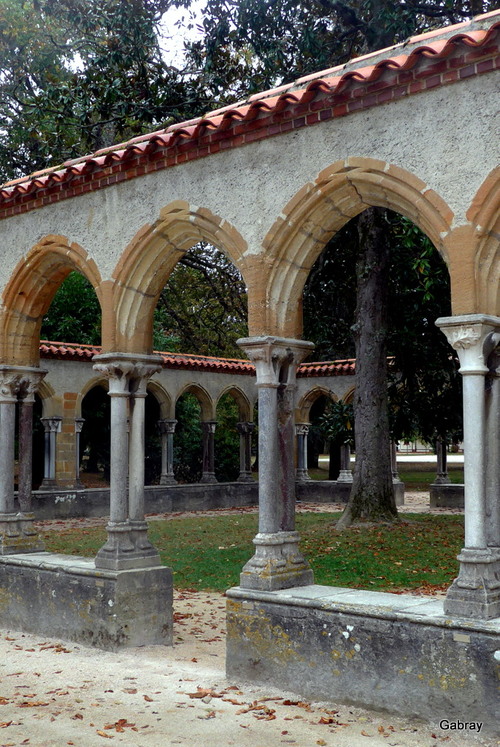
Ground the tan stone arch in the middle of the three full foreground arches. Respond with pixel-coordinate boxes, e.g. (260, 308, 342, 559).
(111, 200, 247, 353)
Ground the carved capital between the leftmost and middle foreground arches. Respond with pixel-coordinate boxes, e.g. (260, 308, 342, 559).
(93, 353, 162, 397)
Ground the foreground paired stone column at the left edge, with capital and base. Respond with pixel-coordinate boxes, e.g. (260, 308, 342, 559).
(0, 366, 47, 555)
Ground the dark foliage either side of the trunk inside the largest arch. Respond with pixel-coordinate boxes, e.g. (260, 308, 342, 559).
(304, 213, 462, 443)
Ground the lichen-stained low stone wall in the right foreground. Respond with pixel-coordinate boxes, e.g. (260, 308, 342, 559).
(226, 585, 500, 744)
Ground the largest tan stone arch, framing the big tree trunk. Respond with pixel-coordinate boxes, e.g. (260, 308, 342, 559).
(259, 158, 453, 338)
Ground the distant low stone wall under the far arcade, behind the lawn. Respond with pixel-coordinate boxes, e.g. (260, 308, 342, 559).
(23, 480, 404, 520)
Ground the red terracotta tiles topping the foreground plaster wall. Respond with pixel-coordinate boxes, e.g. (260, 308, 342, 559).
(0, 10, 500, 202)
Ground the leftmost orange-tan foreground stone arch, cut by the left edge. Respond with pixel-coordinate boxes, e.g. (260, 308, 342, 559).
(0, 235, 104, 366)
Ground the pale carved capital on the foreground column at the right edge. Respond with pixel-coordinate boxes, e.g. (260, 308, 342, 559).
(436, 314, 500, 376)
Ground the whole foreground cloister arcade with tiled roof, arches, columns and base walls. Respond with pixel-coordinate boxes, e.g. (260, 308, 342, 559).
(0, 11, 500, 731)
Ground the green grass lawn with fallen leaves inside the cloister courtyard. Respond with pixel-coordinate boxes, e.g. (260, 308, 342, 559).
(44, 513, 463, 591)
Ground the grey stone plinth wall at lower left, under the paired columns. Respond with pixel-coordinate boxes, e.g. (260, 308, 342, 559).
(0, 552, 172, 651)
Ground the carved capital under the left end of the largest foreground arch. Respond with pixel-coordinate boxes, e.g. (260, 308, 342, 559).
(237, 336, 314, 387)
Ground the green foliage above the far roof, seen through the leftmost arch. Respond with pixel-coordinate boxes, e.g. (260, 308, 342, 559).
(40, 272, 101, 345)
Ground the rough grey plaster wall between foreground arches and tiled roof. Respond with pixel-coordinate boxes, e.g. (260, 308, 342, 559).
(0, 75, 499, 286)
